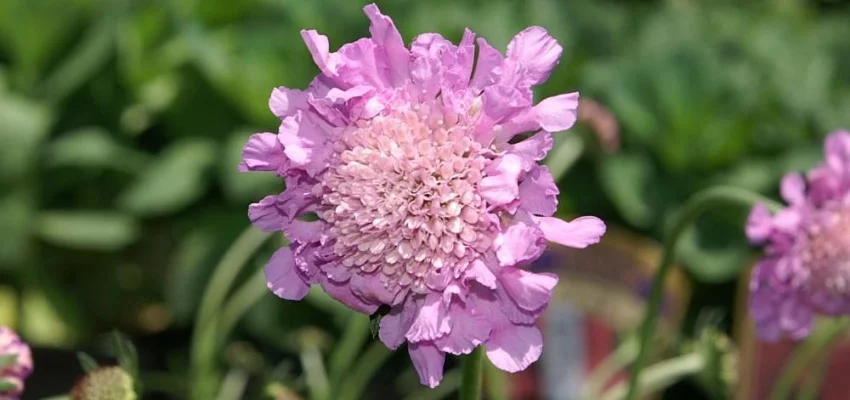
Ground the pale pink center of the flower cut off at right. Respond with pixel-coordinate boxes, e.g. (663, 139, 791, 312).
(802, 210, 850, 296)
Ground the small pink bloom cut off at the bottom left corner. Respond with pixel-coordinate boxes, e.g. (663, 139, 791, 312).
(0, 326, 33, 400)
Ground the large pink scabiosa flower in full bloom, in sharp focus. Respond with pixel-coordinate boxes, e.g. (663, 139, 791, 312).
(240, 5, 605, 387)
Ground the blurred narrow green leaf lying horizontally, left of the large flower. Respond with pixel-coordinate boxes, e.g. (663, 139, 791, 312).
(36, 211, 139, 251)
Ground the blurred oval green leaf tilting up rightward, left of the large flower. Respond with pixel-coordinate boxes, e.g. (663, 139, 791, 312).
(118, 139, 216, 217)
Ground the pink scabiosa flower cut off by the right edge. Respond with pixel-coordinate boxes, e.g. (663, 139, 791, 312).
(746, 131, 850, 340)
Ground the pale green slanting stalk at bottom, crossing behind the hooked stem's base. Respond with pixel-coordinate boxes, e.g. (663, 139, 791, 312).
(600, 352, 705, 400)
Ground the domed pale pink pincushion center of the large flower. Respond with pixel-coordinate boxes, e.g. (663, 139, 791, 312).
(318, 104, 492, 293)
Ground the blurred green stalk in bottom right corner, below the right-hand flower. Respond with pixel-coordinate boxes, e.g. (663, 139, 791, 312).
(770, 319, 850, 400)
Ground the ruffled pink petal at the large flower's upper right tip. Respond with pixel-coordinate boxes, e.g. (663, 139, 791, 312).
(507, 26, 563, 86)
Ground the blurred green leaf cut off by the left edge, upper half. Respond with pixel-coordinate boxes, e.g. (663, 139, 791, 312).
(0, 94, 51, 182)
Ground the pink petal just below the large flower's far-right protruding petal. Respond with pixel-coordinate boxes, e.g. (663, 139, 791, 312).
(499, 267, 558, 311)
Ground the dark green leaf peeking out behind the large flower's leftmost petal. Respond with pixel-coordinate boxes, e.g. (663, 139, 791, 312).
(218, 131, 283, 204)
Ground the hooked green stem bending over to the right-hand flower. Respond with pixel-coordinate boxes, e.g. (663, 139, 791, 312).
(626, 186, 781, 400)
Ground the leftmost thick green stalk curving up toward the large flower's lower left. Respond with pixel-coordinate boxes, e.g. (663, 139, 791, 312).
(190, 226, 271, 400)
